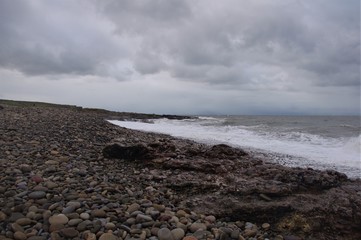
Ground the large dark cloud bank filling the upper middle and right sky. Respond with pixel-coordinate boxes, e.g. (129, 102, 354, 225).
(102, 1, 360, 86)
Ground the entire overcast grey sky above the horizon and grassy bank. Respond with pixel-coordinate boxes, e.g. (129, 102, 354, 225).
(0, 0, 360, 114)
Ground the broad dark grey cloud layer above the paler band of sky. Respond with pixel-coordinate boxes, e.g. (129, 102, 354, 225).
(0, 0, 360, 86)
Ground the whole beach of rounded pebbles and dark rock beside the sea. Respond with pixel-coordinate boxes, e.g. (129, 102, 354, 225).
(0, 104, 361, 240)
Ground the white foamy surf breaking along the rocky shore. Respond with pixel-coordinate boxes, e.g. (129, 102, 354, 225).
(110, 117, 361, 177)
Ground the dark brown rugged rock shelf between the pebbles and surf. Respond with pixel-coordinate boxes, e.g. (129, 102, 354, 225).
(104, 139, 361, 239)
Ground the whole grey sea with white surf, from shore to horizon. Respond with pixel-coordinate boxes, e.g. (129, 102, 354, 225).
(109, 116, 361, 178)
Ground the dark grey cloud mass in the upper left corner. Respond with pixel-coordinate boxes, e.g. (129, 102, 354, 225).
(0, 0, 125, 75)
